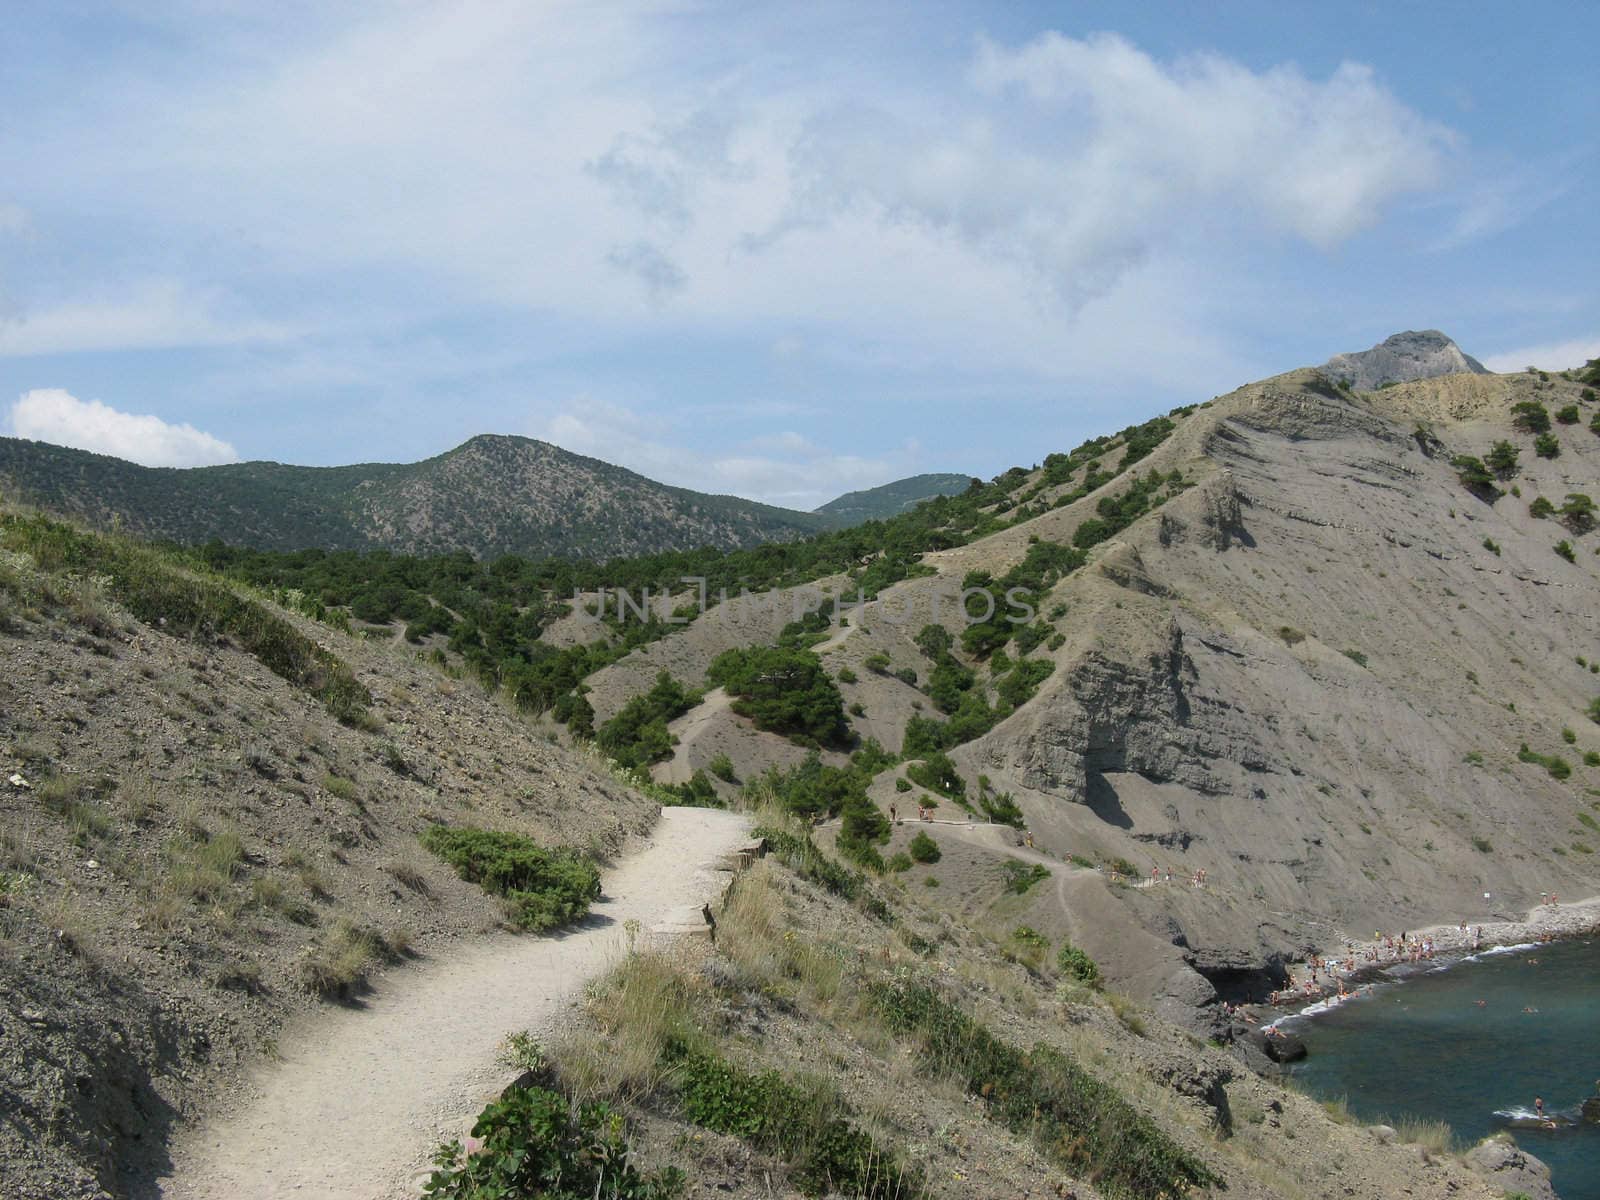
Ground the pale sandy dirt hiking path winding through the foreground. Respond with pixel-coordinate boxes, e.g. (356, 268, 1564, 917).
(158, 808, 749, 1200)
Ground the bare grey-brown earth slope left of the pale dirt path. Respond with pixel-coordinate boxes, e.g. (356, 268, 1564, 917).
(0, 550, 658, 1200)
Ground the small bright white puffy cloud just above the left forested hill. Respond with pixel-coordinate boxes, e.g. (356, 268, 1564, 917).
(11, 387, 238, 467)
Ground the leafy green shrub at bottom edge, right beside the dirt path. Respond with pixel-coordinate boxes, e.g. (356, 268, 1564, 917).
(422, 1088, 685, 1200)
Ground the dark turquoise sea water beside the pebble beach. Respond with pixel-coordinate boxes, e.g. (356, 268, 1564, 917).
(1286, 939, 1600, 1200)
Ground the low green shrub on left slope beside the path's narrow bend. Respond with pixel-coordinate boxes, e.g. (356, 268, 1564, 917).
(422, 826, 600, 933)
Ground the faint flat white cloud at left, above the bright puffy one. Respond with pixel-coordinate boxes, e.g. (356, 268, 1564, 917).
(0, 280, 290, 357)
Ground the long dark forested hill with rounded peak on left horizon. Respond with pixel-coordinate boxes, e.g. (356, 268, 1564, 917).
(0, 435, 842, 558)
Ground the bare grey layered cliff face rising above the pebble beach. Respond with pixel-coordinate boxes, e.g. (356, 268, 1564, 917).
(957, 373, 1600, 1017)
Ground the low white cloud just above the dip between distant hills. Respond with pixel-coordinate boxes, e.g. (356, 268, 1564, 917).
(533, 400, 923, 510)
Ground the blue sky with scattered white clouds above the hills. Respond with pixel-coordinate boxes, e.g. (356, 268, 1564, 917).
(0, 0, 1600, 509)
